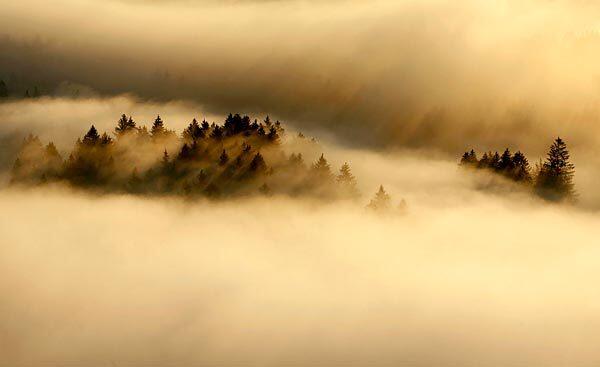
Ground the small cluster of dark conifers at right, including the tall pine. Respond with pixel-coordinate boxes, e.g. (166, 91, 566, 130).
(460, 137, 576, 201)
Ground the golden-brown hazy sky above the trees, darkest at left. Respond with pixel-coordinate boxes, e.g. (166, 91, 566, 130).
(0, 0, 600, 154)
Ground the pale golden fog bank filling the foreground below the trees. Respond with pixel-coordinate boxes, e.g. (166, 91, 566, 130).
(0, 190, 600, 366)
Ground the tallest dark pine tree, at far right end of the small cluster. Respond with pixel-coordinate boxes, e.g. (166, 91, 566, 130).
(535, 137, 575, 201)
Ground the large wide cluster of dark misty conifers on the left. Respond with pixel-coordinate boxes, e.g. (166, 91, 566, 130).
(11, 114, 366, 203)
